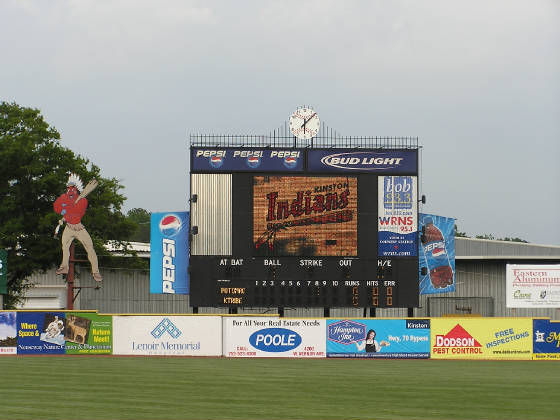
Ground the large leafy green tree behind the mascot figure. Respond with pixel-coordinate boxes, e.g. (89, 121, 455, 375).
(0, 102, 134, 307)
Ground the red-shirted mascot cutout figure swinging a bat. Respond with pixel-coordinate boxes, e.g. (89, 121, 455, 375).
(53, 174, 103, 281)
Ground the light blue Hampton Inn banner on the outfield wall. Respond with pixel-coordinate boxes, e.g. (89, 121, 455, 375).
(327, 319, 430, 359)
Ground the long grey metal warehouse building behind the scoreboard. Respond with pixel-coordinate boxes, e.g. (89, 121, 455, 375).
(8, 238, 560, 320)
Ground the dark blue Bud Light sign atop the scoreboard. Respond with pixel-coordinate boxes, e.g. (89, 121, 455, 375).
(307, 149, 418, 174)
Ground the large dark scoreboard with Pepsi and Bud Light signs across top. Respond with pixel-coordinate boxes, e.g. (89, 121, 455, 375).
(189, 136, 419, 308)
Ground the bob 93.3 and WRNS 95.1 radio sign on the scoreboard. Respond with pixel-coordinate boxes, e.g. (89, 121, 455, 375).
(377, 176, 418, 257)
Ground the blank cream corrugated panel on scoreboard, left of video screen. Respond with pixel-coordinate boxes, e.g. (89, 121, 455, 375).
(190, 174, 232, 255)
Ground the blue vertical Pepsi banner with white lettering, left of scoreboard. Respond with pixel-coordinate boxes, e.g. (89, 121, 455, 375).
(150, 212, 190, 295)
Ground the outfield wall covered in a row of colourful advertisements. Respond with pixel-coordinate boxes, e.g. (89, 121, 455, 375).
(0, 311, 560, 360)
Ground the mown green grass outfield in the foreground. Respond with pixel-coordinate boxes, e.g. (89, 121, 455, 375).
(0, 356, 560, 420)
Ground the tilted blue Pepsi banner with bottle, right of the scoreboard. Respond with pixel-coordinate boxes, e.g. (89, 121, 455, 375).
(418, 213, 455, 295)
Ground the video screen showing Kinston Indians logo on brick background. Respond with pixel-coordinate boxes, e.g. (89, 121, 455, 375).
(253, 176, 358, 257)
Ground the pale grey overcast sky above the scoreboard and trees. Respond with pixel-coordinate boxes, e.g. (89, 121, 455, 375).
(0, 0, 560, 245)
